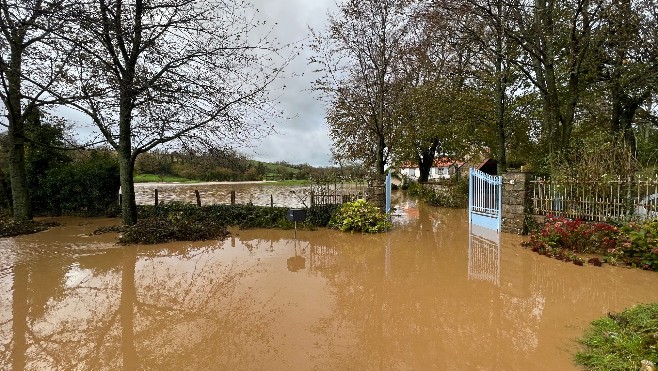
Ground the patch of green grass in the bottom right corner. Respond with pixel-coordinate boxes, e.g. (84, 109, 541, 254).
(576, 303, 658, 370)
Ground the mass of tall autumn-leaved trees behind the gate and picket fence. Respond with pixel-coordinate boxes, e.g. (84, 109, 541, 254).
(310, 0, 658, 179)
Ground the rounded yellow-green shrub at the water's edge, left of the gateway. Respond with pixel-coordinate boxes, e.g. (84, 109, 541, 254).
(329, 199, 391, 233)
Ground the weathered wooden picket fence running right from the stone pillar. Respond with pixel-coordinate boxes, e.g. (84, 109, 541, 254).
(531, 177, 658, 221)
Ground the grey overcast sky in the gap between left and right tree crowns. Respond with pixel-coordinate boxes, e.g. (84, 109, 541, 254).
(243, 0, 336, 166)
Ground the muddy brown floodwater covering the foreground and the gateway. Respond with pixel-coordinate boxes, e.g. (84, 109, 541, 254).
(0, 193, 658, 370)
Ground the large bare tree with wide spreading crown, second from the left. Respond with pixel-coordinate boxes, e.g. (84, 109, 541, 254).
(64, 0, 291, 225)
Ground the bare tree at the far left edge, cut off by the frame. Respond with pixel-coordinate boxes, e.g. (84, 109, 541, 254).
(0, 0, 77, 220)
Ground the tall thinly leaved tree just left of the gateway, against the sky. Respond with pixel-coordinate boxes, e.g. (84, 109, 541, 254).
(311, 0, 412, 174)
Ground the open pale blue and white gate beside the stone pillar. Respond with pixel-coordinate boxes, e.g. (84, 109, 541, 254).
(468, 168, 503, 232)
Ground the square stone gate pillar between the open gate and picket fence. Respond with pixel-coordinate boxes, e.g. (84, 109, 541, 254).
(501, 172, 532, 234)
